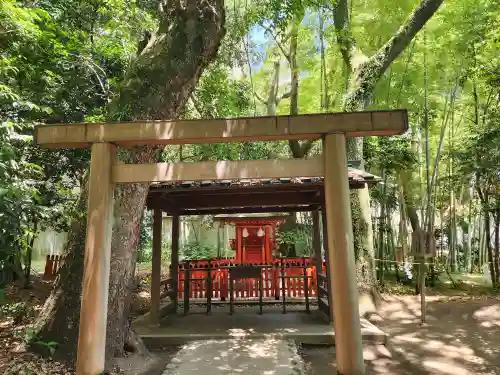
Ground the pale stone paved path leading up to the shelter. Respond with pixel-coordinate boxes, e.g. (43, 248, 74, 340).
(162, 337, 303, 375)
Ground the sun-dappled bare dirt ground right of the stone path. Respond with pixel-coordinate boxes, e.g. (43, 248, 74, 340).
(302, 296, 500, 375)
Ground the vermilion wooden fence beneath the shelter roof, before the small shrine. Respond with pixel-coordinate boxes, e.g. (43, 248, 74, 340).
(177, 258, 325, 300)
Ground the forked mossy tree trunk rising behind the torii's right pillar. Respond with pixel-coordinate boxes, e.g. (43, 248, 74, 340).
(334, 0, 443, 296)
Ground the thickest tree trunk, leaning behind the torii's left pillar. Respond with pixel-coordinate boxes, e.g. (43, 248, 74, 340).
(33, 0, 225, 361)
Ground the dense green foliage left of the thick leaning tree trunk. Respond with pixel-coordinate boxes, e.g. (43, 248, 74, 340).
(0, 0, 155, 280)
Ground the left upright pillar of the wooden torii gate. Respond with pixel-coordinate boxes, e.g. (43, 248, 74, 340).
(76, 143, 116, 375)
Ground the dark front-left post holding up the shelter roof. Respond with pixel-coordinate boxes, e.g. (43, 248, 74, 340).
(150, 208, 163, 324)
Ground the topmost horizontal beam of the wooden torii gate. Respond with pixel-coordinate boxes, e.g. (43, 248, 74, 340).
(35, 110, 408, 148)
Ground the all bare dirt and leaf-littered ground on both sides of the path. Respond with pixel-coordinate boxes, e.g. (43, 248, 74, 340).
(0, 274, 500, 375)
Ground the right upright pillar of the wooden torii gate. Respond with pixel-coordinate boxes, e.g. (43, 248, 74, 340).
(323, 134, 364, 375)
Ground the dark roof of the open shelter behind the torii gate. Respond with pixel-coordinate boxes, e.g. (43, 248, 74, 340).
(147, 161, 380, 215)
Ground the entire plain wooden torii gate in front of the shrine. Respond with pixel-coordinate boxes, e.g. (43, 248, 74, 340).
(35, 110, 408, 375)
